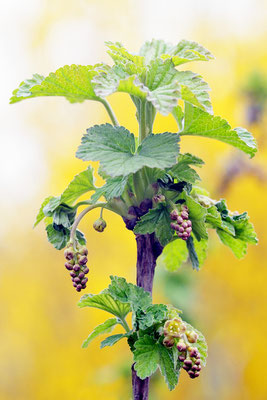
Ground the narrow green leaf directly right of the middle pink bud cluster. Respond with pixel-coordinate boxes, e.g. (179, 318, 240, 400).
(180, 192, 208, 240)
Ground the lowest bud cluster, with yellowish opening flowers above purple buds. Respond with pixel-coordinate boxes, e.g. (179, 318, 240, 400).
(163, 318, 201, 379)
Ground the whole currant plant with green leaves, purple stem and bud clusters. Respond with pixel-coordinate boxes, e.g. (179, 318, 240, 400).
(11, 40, 257, 400)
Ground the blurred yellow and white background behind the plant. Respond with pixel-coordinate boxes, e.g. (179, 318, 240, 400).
(0, 0, 267, 400)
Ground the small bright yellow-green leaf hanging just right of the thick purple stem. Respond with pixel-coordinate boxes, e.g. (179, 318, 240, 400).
(157, 239, 188, 272)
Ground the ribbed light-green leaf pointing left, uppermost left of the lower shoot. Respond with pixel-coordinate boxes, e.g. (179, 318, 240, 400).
(78, 290, 130, 319)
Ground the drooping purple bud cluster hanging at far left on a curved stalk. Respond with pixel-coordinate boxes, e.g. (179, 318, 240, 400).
(64, 243, 89, 292)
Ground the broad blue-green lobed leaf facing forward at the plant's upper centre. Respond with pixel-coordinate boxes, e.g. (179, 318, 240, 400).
(76, 124, 179, 177)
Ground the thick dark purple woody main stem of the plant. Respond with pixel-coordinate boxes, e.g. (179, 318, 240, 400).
(132, 233, 163, 400)
